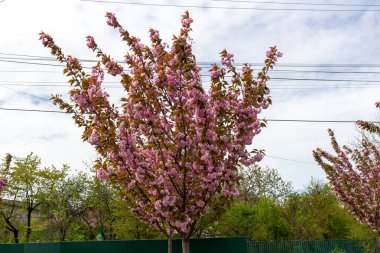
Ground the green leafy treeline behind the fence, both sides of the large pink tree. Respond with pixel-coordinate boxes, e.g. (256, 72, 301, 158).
(0, 154, 375, 243)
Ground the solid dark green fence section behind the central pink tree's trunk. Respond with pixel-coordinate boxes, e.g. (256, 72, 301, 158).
(0, 237, 247, 253)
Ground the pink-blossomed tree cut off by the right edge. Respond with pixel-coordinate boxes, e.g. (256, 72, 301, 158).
(313, 102, 380, 235)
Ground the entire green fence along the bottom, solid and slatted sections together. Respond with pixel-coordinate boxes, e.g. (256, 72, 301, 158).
(0, 237, 372, 253)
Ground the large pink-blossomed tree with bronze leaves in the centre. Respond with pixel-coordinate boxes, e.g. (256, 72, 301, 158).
(40, 12, 282, 253)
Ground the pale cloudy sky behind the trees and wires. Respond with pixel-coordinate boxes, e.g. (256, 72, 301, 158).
(0, 0, 380, 189)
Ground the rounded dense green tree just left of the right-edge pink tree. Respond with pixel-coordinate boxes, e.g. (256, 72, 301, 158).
(282, 181, 353, 240)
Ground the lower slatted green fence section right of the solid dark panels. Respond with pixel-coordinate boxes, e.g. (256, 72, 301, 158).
(248, 240, 362, 253)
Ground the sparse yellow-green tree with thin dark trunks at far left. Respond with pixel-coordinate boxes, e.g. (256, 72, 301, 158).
(1, 153, 63, 243)
